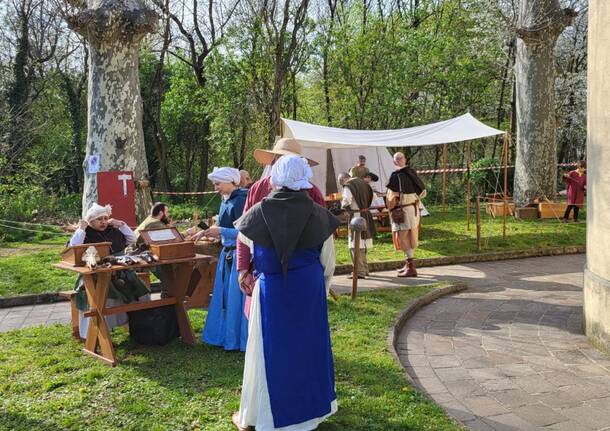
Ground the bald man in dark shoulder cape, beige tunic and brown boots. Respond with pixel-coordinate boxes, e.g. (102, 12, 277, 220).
(386, 152, 426, 277)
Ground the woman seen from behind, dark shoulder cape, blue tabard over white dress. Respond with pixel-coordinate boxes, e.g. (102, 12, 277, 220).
(232, 156, 339, 431)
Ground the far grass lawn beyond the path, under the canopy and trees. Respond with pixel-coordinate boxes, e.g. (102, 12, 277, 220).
(0, 207, 586, 297)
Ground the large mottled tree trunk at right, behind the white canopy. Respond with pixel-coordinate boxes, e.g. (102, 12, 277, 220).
(514, 0, 575, 206)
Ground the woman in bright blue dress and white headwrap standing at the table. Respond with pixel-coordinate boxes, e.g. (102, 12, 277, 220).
(194, 168, 248, 352)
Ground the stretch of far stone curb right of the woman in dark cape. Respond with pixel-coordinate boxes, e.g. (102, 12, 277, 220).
(335, 246, 587, 275)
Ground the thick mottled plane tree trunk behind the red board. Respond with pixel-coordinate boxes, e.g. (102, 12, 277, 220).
(68, 0, 159, 220)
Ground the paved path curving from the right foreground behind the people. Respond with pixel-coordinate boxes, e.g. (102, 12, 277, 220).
(0, 255, 610, 431)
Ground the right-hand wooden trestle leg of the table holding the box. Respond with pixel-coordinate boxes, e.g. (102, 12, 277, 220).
(162, 262, 196, 344)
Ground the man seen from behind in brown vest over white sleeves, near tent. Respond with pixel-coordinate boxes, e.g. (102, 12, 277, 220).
(338, 172, 375, 278)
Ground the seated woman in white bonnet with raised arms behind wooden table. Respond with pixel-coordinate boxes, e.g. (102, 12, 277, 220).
(68, 203, 150, 338)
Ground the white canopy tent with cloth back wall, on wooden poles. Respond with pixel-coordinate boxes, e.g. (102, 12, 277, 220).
(282, 113, 504, 195)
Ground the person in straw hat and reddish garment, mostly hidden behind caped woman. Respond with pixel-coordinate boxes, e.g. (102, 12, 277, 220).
(236, 138, 325, 276)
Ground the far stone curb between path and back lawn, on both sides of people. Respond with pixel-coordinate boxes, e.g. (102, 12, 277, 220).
(0, 246, 587, 308)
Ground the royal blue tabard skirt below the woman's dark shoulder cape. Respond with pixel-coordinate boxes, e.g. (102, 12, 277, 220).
(254, 244, 337, 428)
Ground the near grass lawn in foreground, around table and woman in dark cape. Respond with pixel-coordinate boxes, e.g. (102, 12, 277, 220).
(0, 286, 461, 431)
